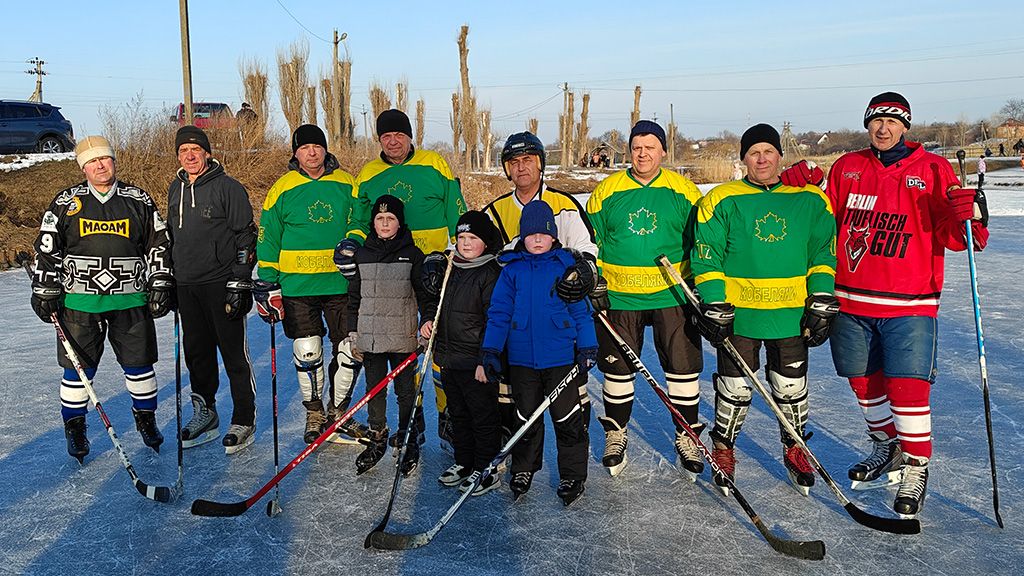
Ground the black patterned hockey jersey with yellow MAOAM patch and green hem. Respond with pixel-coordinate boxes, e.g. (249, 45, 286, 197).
(34, 180, 173, 313)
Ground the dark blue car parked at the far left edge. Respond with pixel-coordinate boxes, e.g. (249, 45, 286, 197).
(0, 100, 75, 154)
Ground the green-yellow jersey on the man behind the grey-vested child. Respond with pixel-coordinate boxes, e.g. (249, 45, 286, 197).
(348, 150, 466, 254)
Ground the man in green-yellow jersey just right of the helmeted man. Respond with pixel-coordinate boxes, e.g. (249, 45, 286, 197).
(587, 120, 703, 481)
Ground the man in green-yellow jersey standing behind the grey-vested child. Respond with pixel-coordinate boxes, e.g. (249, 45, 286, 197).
(335, 109, 466, 453)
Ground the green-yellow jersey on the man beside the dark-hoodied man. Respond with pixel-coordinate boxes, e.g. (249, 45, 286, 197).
(256, 169, 355, 296)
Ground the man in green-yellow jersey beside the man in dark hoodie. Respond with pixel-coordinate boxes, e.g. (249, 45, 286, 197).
(253, 124, 367, 443)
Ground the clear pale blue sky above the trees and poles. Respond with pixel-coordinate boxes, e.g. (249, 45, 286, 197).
(0, 0, 1024, 141)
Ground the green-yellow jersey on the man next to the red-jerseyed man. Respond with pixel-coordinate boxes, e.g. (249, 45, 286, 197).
(691, 178, 836, 339)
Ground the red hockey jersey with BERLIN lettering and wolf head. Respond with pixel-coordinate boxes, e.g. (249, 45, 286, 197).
(825, 141, 967, 318)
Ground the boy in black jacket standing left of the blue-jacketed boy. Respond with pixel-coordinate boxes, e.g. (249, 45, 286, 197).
(420, 210, 502, 496)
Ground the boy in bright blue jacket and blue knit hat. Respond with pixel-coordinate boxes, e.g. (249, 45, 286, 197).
(481, 202, 597, 506)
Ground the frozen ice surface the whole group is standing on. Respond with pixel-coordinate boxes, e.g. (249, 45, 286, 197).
(0, 170, 1024, 576)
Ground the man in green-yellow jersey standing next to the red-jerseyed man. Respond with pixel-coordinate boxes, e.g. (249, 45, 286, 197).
(691, 124, 839, 495)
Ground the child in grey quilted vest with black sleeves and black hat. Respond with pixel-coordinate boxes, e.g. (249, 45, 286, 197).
(348, 194, 428, 476)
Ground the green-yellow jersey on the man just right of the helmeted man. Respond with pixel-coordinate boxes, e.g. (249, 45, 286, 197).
(587, 166, 700, 310)
